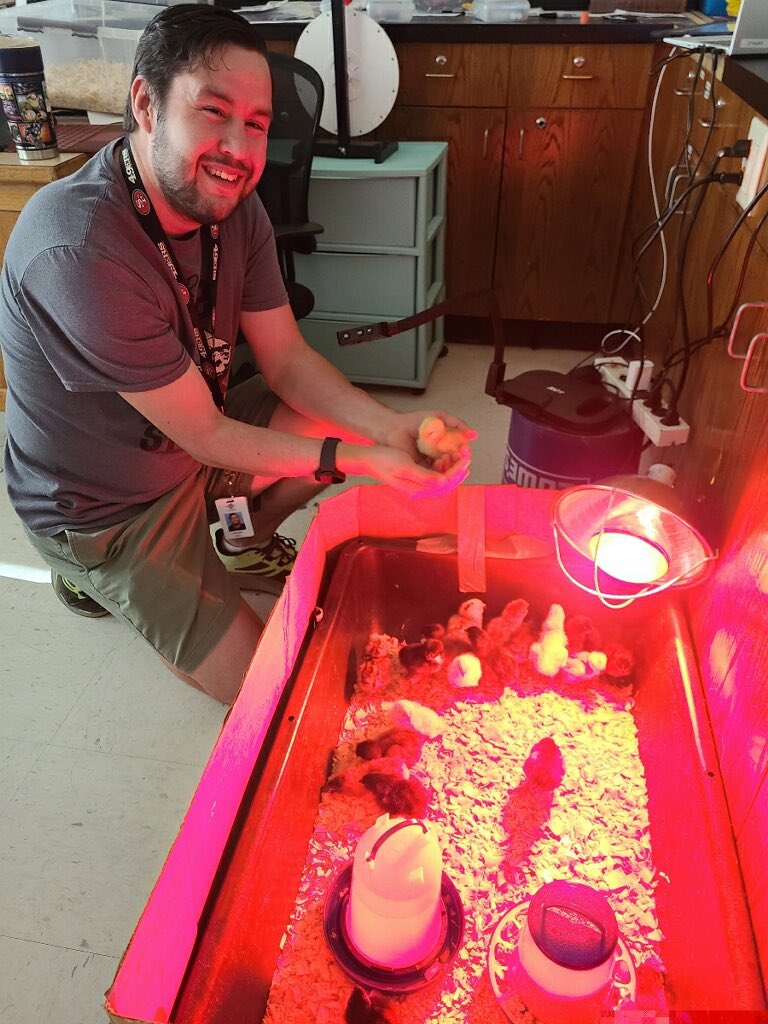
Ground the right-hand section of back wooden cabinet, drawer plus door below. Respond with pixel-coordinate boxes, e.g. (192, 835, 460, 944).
(495, 45, 653, 324)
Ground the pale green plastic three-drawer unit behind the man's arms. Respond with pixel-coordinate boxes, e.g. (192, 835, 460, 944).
(295, 142, 447, 390)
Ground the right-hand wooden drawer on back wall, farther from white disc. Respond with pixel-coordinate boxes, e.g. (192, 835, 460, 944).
(509, 44, 653, 110)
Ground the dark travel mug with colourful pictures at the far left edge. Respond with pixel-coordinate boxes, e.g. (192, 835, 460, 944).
(0, 39, 58, 160)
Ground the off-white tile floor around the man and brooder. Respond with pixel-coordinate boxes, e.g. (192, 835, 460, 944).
(0, 345, 582, 1024)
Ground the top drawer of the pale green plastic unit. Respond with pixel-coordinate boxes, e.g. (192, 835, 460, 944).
(309, 177, 417, 248)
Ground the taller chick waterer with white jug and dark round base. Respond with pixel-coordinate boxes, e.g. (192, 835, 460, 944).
(324, 814, 464, 992)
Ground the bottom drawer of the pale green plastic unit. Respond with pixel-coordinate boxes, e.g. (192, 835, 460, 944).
(299, 316, 417, 384)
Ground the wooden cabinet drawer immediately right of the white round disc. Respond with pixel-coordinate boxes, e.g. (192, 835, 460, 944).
(395, 43, 509, 106)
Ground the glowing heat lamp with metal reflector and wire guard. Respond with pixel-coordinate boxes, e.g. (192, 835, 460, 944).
(552, 475, 716, 607)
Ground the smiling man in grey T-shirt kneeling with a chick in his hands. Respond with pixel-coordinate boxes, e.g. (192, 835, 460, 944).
(0, 4, 474, 702)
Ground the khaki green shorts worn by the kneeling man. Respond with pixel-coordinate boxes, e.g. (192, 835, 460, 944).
(27, 377, 279, 674)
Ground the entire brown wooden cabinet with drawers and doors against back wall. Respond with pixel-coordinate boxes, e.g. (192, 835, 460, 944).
(379, 43, 653, 324)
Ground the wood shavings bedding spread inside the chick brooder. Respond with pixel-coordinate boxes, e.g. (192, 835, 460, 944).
(264, 602, 664, 1024)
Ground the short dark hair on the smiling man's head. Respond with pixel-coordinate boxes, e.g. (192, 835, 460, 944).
(123, 3, 266, 131)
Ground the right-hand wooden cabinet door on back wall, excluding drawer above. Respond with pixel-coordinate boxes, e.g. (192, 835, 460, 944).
(495, 106, 642, 324)
